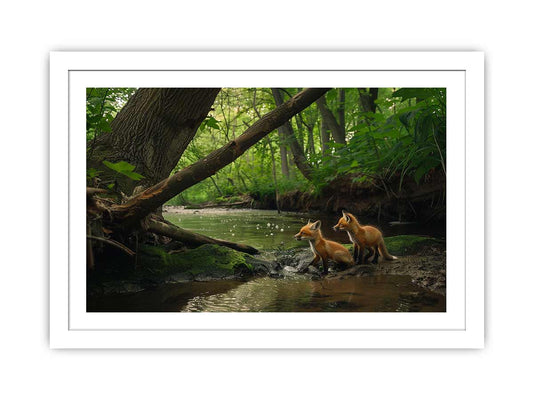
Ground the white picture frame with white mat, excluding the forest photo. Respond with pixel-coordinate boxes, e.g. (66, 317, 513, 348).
(50, 52, 484, 348)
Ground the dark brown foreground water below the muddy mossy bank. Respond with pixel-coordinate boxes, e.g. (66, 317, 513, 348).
(87, 275, 446, 312)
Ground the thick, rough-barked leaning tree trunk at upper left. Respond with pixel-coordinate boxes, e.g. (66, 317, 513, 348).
(87, 88, 220, 194)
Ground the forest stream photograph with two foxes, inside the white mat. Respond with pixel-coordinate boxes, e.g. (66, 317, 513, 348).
(86, 87, 447, 313)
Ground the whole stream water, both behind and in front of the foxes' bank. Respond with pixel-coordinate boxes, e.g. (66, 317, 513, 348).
(87, 208, 446, 312)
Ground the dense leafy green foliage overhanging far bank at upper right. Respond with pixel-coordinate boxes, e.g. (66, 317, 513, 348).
(314, 88, 446, 190)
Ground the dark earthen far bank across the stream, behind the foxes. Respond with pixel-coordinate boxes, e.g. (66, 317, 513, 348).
(164, 172, 446, 224)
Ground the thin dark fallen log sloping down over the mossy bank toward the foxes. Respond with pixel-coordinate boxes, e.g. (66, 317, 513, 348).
(145, 219, 259, 254)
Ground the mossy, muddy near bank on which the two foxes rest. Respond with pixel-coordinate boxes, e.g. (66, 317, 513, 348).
(87, 235, 446, 297)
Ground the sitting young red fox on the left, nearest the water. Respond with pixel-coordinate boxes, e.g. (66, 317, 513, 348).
(294, 221, 354, 274)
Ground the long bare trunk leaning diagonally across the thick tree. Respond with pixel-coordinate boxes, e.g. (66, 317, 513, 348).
(112, 88, 329, 226)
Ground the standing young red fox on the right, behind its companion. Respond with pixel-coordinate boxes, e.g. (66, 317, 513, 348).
(333, 211, 398, 264)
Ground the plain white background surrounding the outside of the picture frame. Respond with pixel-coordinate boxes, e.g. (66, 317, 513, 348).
(0, 1, 533, 399)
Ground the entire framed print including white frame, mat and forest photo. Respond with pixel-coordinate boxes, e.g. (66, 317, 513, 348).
(50, 52, 484, 348)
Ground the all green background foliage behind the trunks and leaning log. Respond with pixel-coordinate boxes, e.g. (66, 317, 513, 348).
(87, 88, 446, 205)
